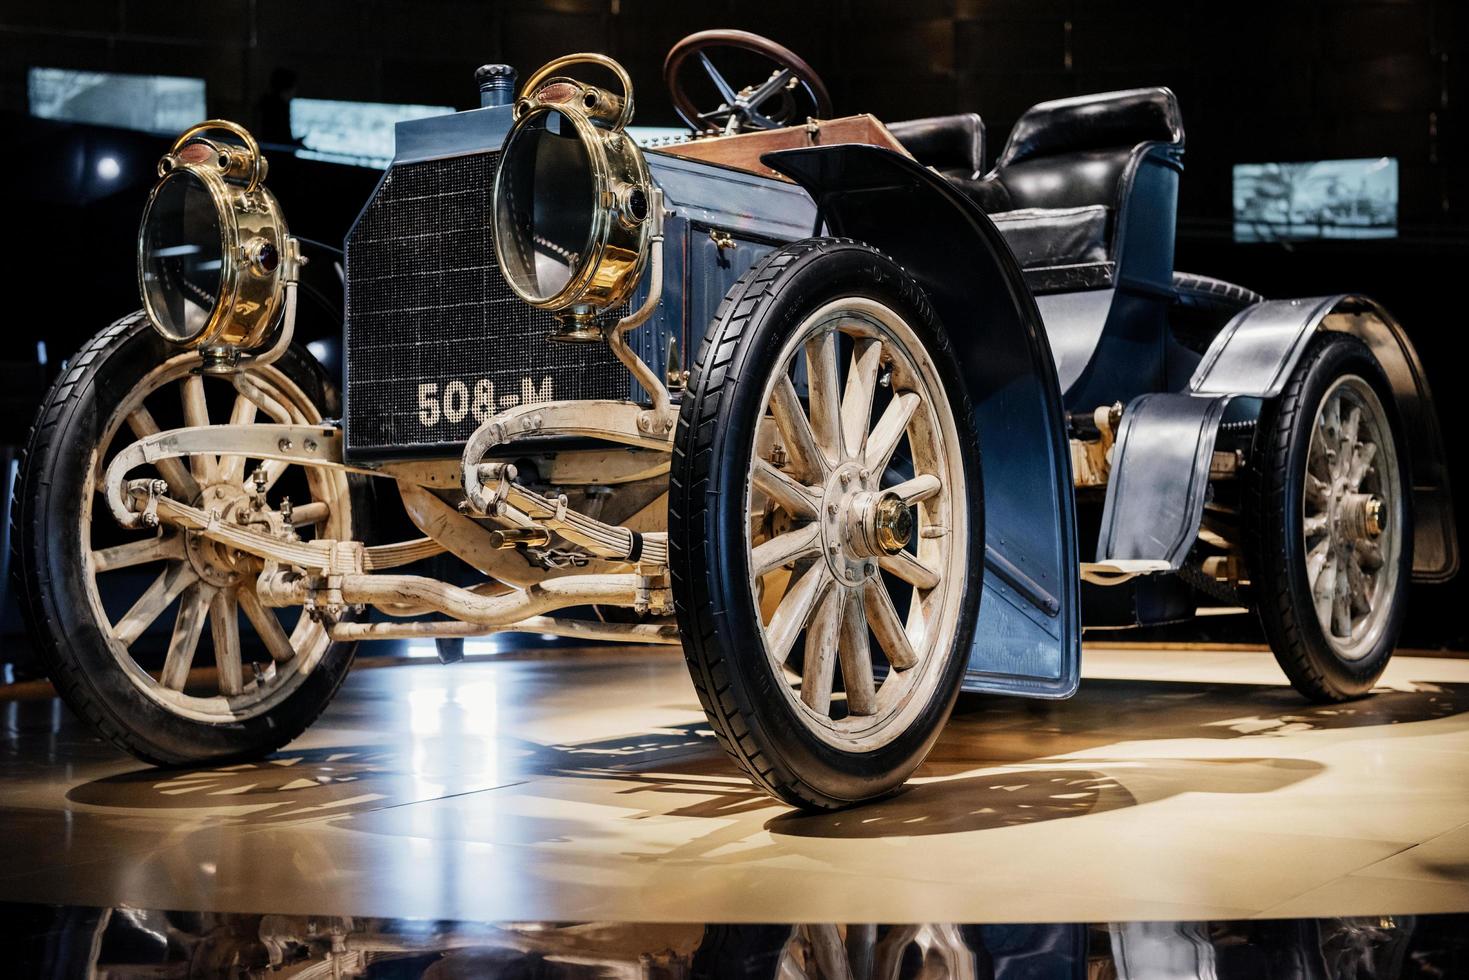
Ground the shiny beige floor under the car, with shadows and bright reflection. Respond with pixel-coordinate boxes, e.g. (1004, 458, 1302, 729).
(0, 651, 1469, 923)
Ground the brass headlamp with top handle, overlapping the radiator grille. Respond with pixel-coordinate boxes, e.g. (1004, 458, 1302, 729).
(495, 54, 657, 341)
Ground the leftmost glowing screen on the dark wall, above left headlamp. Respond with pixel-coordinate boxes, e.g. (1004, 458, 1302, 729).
(26, 68, 206, 132)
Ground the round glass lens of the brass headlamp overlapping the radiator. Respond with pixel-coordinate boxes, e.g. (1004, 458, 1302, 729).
(495, 110, 596, 300)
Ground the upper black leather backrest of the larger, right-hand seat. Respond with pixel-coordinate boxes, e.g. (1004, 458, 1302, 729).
(974, 87, 1184, 213)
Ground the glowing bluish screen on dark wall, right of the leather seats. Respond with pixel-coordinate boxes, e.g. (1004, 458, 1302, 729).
(1234, 157, 1397, 241)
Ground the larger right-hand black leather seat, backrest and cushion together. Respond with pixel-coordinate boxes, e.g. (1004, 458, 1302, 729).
(953, 88, 1184, 292)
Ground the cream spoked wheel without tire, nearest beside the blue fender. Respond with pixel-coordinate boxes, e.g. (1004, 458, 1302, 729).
(746, 297, 970, 748)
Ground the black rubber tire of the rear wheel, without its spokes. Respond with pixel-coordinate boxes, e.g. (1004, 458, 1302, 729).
(1244, 332, 1413, 702)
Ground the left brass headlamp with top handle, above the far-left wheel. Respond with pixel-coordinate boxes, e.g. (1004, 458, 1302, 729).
(138, 119, 301, 357)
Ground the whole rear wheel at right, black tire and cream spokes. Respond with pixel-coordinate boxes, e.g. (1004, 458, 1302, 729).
(1247, 334, 1413, 701)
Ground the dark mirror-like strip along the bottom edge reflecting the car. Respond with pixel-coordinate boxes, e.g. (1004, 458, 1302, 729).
(0, 905, 1469, 980)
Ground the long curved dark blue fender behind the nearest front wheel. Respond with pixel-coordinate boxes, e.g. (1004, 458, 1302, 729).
(762, 144, 1081, 698)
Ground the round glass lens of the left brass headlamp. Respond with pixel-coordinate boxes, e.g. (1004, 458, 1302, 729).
(141, 170, 225, 341)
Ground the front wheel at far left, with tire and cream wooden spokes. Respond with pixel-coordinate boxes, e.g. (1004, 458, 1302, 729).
(13, 314, 365, 764)
